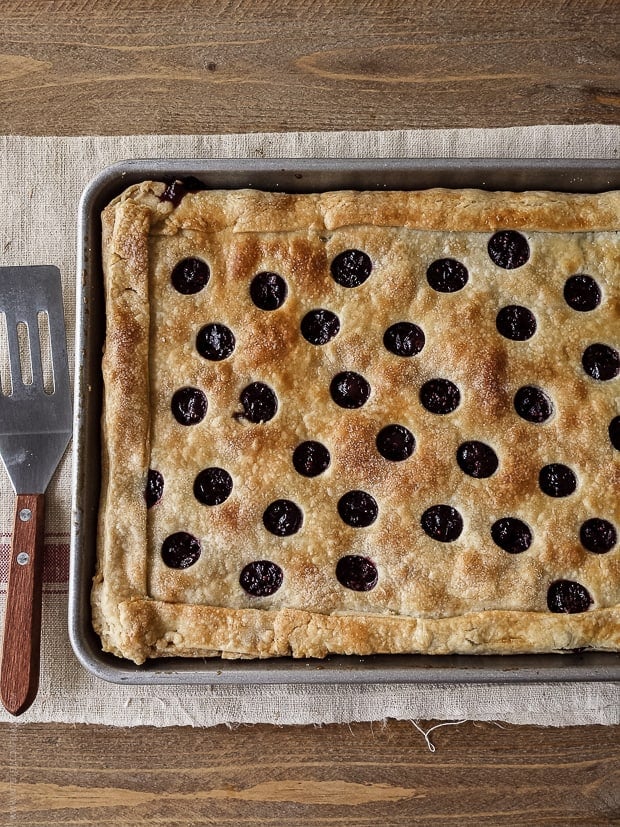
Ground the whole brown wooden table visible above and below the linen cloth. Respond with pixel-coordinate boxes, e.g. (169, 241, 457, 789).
(0, 0, 620, 827)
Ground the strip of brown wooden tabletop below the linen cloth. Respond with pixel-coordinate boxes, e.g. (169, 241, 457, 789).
(0, 722, 620, 827)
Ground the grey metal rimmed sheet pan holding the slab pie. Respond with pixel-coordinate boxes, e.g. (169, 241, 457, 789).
(69, 159, 620, 685)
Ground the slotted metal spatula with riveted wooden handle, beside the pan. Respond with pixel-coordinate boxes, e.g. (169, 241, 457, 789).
(0, 267, 71, 715)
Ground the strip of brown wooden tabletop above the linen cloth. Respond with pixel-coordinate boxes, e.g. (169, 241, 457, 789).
(0, 0, 620, 135)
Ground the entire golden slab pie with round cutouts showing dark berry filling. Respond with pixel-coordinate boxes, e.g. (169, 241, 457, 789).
(92, 182, 620, 663)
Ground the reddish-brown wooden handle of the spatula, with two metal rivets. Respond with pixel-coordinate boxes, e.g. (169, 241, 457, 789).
(0, 494, 45, 715)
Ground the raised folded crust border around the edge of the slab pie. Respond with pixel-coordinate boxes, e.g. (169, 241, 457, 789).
(91, 182, 620, 664)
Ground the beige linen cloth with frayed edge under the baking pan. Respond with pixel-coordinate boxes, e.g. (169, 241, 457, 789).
(0, 125, 620, 726)
